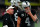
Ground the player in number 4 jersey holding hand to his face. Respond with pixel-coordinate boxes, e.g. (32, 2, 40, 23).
(17, 1, 38, 27)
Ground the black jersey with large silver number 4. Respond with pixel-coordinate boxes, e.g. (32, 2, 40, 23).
(18, 10, 36, 27)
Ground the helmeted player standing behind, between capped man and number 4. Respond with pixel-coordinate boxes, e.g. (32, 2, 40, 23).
(11, 0, 21, 27)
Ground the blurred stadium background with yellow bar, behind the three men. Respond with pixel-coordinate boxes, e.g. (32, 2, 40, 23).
(0, 0, 40, 27)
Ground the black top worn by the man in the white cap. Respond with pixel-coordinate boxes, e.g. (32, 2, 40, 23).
(2, 13, 14, 27)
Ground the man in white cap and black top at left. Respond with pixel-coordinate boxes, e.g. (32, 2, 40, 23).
(2, 6, 14, 27)
